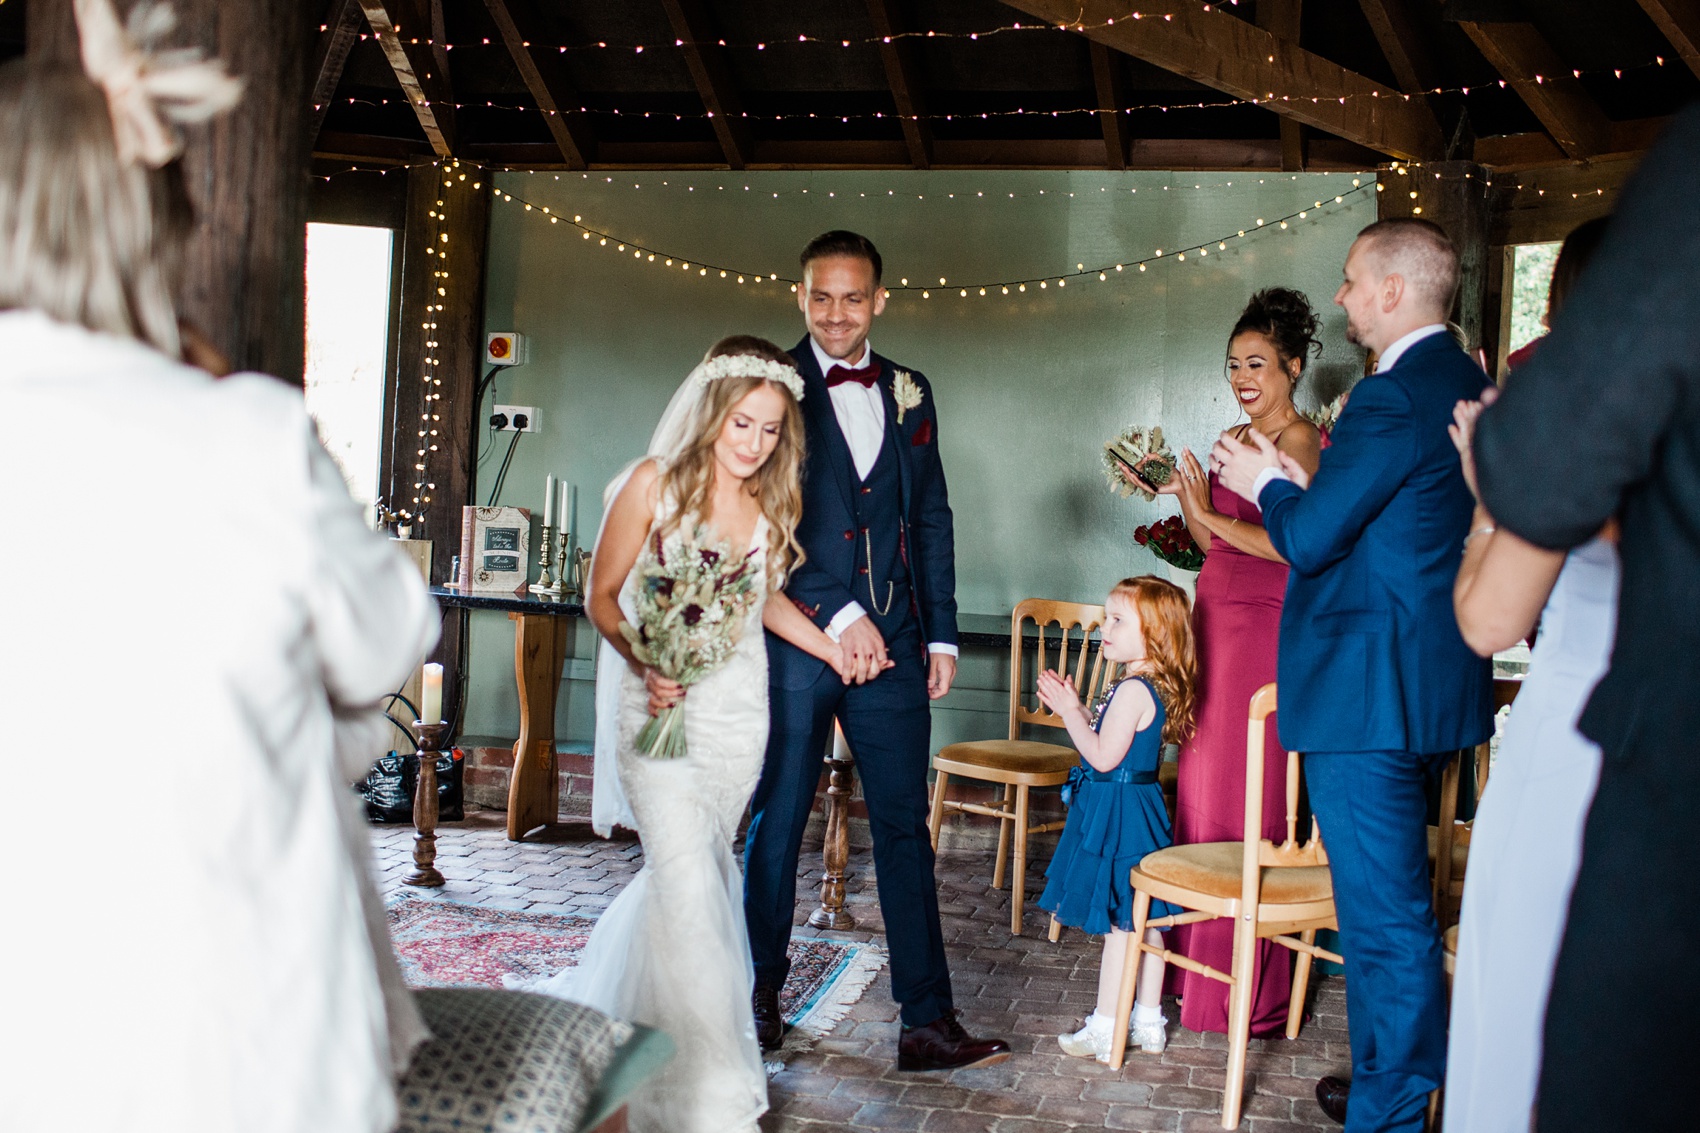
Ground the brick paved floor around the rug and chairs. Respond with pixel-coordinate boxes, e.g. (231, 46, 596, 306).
(372, 810, 1352, 1133)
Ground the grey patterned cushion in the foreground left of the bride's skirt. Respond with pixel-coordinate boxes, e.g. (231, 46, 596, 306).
(396, 987, 634, 1133)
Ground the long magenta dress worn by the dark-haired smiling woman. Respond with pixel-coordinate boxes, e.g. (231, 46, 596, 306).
(1171, 473, 1294, 1036)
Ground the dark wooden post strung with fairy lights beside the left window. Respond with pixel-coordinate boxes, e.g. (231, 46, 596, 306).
(379, 158, 491, 723)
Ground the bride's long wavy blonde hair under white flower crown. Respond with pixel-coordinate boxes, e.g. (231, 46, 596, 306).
(658, 335, 804, 590)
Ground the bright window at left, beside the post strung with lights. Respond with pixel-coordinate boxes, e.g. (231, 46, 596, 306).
(306, 225, 394, 522)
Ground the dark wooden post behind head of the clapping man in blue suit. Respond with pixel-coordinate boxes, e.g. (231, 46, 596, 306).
(1377, 162, 1493, 350)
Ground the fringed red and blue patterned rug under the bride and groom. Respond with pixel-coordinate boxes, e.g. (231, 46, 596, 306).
(389, 893, 886, 1060)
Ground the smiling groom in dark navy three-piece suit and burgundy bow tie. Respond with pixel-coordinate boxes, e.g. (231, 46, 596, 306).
(745, 231, 1010, 1070)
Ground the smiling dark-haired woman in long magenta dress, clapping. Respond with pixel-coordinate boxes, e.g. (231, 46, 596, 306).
(1135, 288, 1321, 1036)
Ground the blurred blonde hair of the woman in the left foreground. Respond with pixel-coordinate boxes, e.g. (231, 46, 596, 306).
(0, 60, 192, 357)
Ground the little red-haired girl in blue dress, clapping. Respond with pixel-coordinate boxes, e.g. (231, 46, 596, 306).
(1039, 575, 1197, 1062)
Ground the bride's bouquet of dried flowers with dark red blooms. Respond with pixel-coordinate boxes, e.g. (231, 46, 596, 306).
(621, 526, 762, 759)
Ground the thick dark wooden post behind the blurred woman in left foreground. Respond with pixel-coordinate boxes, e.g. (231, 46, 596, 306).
(26, 0, 316, 384)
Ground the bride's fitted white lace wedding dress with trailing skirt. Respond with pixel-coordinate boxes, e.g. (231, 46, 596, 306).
(529, 519, 768, 1133)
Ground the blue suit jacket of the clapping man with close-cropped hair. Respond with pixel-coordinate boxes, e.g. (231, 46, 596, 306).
(1258, 333, 1493, 754)
